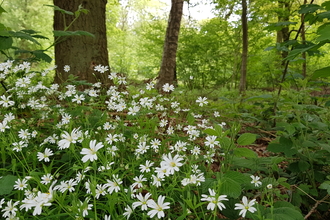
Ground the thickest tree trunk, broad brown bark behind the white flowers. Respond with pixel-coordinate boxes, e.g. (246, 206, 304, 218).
(54, 0, 112, 86)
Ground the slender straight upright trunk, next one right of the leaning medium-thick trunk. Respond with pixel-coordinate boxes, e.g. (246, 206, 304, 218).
(239, 0, 248, 93)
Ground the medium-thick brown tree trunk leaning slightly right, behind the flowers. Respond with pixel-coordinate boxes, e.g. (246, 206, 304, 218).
(156, 0, 184, 91)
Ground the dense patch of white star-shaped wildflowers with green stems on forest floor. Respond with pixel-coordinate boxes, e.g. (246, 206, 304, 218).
(0, 61, 261, 219)
